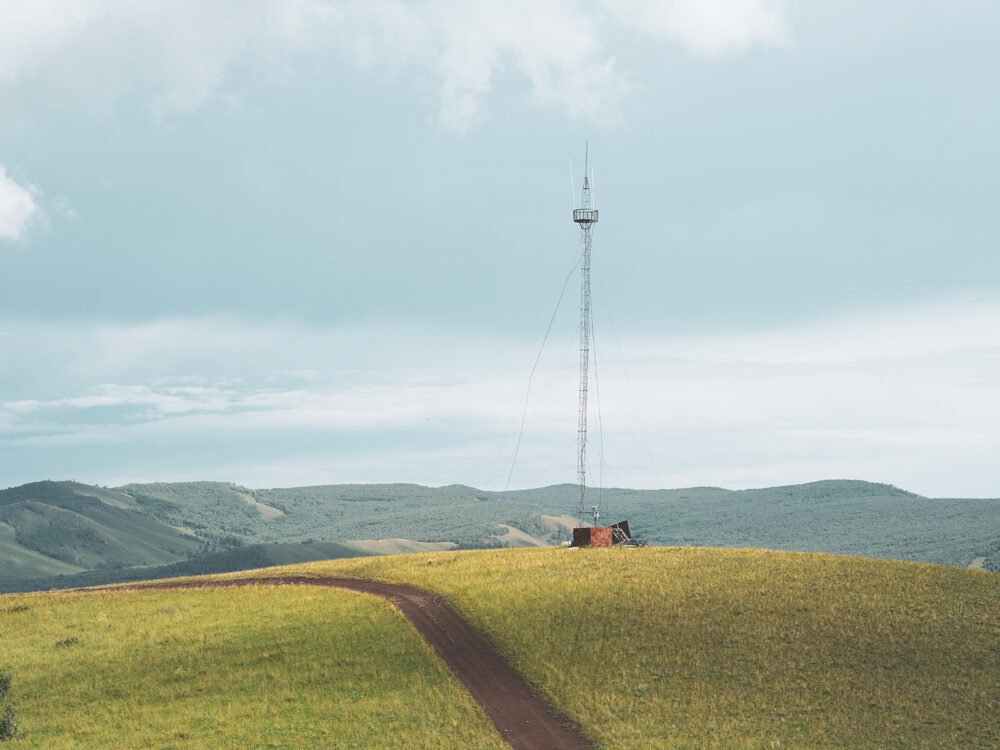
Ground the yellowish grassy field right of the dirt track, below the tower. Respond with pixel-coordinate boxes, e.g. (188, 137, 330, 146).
(268, 548, 1000, 750)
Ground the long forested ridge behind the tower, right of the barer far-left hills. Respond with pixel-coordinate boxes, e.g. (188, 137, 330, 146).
(121, 480, 1000, 569)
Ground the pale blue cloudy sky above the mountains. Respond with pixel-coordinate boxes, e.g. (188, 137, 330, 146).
(0, 0, 1000, 497)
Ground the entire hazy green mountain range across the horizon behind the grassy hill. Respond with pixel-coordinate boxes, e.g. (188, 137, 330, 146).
(0, 480, 1000, 590)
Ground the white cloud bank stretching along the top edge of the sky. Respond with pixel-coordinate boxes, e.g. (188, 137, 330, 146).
(0, 0, 788, 131)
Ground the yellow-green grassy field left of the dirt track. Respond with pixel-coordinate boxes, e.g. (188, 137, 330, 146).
(0, 587, 503, 750)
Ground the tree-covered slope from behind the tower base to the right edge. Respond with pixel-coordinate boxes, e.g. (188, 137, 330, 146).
(510, 480, 1000, 569)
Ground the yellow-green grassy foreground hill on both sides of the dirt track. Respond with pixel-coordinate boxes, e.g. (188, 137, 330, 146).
(0, 548, 1000, 750)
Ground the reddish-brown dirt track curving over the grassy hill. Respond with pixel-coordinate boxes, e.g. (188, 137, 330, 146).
(88, 576, 592, 750)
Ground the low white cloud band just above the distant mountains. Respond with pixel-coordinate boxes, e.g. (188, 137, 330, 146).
(0, 299, 1000, 497)
